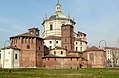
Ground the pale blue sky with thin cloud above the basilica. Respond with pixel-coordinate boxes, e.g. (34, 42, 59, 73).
(0, 0, 119, 47)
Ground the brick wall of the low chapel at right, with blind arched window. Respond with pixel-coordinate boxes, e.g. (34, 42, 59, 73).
(83, 51, 106, 68)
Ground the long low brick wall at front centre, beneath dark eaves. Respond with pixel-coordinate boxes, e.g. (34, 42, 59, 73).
(44, 58, 81, 68)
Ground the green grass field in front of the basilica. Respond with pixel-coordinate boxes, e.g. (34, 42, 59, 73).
(0, 68, 119, 78)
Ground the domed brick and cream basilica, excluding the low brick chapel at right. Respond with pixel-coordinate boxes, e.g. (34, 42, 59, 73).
(1, 1, 87, 68)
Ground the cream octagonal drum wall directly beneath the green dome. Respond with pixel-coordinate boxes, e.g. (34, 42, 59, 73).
(42, 19, 74, 38)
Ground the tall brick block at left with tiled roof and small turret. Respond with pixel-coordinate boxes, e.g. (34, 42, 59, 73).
(10, 28, 44, 68)
